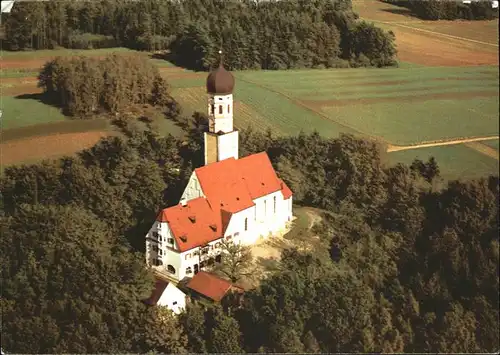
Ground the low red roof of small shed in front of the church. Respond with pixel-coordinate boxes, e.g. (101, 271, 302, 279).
(186, 271, 243, 302)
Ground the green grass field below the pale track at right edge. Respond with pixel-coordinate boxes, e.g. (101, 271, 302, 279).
(388, 141, 499, 180)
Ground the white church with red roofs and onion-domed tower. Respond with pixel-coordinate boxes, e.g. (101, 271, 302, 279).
(146, 52, 292, 281)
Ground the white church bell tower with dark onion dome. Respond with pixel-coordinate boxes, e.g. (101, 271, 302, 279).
(204, 51, 238, 165)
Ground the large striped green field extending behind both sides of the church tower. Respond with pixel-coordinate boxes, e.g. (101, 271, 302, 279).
(167, 67, 499, 145)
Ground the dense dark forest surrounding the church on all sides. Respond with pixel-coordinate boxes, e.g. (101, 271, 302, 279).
(0, 114, 499, 353)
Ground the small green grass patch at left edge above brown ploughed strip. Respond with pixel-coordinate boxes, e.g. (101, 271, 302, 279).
(0, 96, 67, 129)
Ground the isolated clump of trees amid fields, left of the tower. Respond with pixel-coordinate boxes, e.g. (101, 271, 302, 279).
(38, 54, 179, 118)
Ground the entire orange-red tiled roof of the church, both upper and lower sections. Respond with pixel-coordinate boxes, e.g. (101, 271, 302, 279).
(157, 152, 292, 252)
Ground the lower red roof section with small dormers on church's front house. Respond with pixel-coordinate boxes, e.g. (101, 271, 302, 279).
(156, 197, 222, 252)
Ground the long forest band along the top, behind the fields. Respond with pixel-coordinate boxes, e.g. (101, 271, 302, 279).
(2, 0, 396, 70)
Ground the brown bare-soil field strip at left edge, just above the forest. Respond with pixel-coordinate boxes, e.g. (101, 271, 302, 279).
(0, 131, 109, 166)
